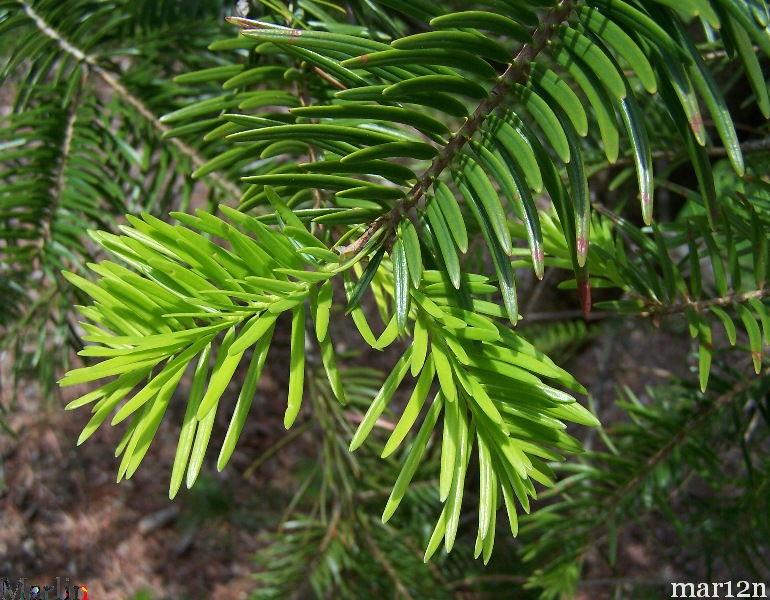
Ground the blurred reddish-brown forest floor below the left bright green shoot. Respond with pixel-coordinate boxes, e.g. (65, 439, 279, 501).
(0, 350, 301, 600)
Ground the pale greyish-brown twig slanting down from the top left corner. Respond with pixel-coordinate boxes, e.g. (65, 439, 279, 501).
(18, 0, 241, 198)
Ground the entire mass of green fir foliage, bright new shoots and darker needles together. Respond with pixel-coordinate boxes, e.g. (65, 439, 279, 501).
(0, 0, 770, 598)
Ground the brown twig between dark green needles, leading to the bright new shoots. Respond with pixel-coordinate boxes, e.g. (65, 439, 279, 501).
(337, 0, 574, 254)
